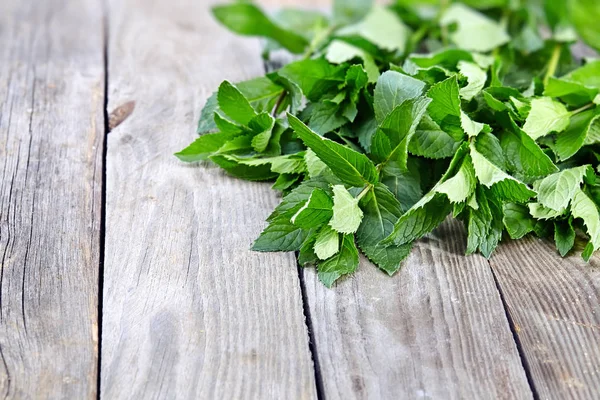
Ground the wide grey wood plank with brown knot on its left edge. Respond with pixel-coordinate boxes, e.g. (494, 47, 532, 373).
(101, 0, 315, 399)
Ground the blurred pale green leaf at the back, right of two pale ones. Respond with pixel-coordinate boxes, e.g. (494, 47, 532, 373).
(440, 3, 510, 52)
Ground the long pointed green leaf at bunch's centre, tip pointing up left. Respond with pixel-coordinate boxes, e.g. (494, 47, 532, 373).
(288, 114, 379, 186)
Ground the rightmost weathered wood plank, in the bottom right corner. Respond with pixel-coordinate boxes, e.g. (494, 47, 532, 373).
(491, 238, 600, 399)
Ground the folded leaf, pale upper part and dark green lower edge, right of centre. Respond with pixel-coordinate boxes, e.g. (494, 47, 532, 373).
(470, 143, 535, 203)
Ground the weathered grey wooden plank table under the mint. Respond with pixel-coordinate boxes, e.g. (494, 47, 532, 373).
(0, 0, 600, 399)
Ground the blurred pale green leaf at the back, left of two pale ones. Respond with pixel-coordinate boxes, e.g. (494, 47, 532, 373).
(337, 6, 410, 54)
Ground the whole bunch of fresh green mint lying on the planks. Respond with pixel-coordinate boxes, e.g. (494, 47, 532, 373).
(177, 0, 600, 287)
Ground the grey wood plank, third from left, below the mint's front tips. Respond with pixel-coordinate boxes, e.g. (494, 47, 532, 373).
(304, 221, 532, 399)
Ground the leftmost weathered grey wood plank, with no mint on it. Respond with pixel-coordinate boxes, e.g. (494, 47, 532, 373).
(0, 0, 104, 399)
